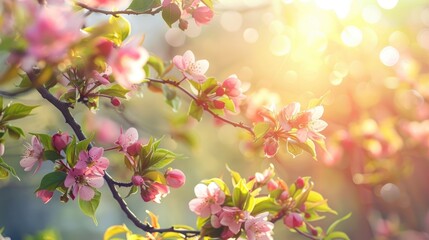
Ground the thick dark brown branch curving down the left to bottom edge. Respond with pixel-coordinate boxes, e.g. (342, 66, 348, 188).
(27, 69, 200, 238)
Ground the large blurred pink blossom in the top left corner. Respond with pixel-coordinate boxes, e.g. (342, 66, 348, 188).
(24, 5, 84, 62)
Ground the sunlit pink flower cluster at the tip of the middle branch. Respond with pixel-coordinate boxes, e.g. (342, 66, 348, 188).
(261, 102, 328, 158)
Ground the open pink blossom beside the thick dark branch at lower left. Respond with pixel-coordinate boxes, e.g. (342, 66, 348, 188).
(75, 147, 109, 175)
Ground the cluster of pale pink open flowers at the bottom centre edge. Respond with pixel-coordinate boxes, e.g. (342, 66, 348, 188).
(189, 182, 274, 240)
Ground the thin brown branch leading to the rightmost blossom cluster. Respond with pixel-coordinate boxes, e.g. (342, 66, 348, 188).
(147, 78, 255, 136)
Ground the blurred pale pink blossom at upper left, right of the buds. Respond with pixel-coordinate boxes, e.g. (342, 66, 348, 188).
(107, 40, 149, 89)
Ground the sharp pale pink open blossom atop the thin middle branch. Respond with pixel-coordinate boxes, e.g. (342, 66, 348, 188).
(173, 50, 209, 83)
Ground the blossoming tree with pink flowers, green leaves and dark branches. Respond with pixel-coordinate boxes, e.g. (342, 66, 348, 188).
(0, 0, 349, 239)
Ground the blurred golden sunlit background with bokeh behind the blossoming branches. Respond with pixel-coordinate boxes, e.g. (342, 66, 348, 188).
(0, 0, 429, 240)
